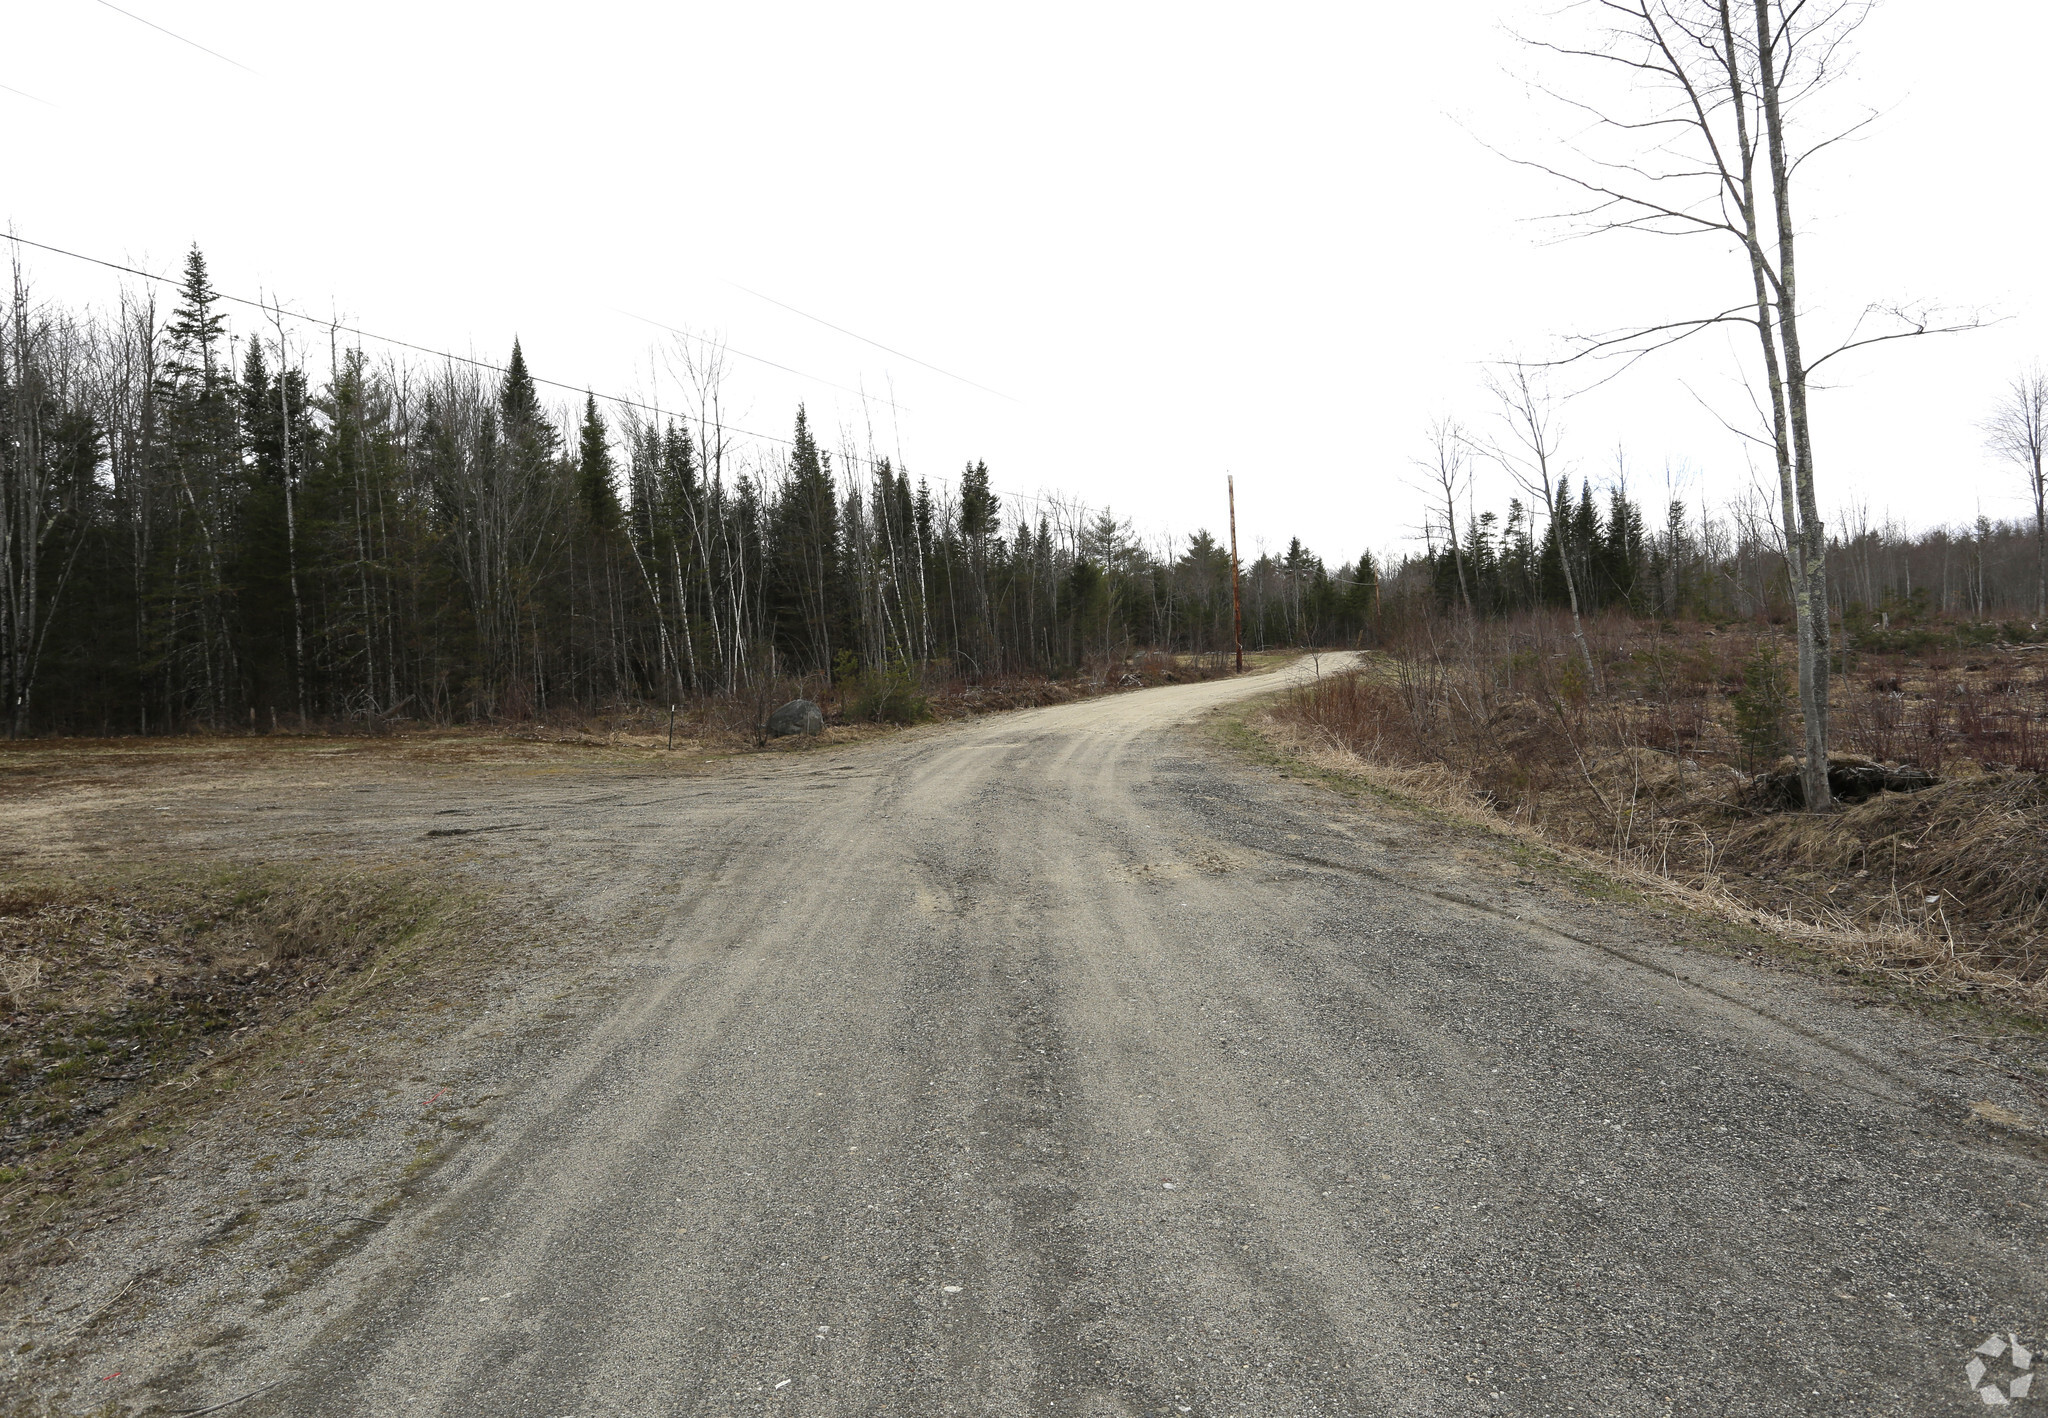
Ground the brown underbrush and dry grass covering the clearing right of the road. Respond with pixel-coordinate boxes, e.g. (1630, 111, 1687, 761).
(1274, 617, 2048, 1010)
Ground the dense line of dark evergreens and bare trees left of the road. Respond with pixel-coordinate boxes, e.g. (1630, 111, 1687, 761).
(0, 248, 1376, 736)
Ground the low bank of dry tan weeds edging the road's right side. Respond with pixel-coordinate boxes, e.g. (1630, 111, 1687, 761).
(1272, 658, 2048, 1012)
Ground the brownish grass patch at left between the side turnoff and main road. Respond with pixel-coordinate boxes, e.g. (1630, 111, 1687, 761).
(0, 861, 479, 1289)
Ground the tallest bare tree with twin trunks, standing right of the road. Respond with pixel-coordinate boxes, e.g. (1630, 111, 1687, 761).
(1516, 0, 1968, 811)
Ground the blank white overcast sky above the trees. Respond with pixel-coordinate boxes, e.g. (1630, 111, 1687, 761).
(0, 0, 2048, 561)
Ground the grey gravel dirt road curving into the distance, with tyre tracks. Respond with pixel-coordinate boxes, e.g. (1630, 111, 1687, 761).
(19, 670, 2048, 1418)
